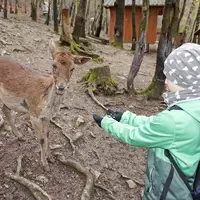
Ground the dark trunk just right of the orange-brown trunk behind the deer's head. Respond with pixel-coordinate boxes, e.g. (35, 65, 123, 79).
(72, 0, 87, 43)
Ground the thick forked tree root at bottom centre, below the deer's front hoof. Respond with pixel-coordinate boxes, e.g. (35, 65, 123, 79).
(55, 153, 116, 200)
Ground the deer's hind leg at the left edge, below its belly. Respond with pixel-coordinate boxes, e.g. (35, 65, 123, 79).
(2, 104, 22, 139)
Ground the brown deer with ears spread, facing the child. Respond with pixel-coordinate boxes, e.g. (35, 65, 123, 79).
(0, 41, 91, 170)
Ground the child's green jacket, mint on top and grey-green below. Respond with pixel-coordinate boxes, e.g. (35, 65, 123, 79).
(101, 100, 200, 200)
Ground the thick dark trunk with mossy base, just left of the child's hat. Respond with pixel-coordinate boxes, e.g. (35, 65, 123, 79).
(146, 0, 177, 99)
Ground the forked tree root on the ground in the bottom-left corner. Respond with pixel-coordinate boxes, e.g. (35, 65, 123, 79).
(5, 156, 52, 200)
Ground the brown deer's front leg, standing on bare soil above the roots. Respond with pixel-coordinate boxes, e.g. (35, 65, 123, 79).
(30, 116, 49, 171)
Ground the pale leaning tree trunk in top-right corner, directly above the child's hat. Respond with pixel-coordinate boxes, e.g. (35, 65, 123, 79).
(182, 0, 200, 43)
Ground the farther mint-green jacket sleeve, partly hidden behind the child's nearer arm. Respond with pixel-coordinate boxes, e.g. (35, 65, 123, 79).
(120, 111, 152, 127)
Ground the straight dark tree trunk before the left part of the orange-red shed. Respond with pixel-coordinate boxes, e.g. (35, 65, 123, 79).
(114, 0, 125, 48)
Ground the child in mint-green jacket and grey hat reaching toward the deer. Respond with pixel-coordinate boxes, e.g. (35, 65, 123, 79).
(93, 43, 200, 200)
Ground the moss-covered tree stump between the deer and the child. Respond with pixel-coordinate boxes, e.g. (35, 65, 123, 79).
(83, 66, 118, 95)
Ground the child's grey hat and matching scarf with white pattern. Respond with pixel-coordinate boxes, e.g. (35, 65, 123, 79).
(163, 43, 200, 106)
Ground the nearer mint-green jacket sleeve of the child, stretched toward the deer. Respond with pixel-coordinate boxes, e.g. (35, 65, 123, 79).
(101, 111, 175, 148)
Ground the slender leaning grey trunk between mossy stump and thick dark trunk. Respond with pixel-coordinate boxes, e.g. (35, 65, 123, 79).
(127, 0, 149, 92)
